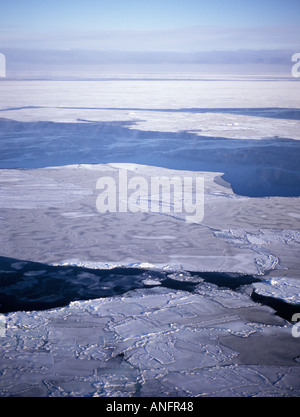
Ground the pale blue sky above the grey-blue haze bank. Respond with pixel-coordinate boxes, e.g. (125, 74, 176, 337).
(0, 0, 300, 76)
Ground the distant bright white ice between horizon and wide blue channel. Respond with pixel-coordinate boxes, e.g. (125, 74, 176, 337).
(0, 77, 300, 140)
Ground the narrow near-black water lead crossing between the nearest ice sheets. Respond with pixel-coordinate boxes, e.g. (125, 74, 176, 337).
(0, 257, 300, 321)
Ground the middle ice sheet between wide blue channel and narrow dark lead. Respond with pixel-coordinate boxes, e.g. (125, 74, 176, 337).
(0, 164, 299, 278)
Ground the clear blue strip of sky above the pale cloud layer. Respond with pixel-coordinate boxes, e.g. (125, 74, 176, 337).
(0, 0, 300, 30)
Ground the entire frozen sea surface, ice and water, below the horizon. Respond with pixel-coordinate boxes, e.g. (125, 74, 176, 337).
(0, 77, 300, 397)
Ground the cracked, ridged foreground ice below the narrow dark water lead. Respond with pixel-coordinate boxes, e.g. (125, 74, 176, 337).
(0, 284, 300, 396)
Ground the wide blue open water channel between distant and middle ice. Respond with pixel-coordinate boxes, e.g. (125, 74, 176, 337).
(0, 115, 300, 197)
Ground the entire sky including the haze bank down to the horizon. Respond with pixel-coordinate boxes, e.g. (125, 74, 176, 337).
(0, 0, 300, 74)
